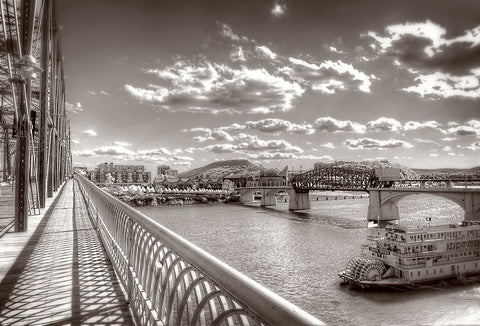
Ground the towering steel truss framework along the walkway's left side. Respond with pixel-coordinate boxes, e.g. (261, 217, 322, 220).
(0, 0, 72, 231)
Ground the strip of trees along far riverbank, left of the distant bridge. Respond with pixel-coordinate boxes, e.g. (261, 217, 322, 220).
(102, 186, 239, 207)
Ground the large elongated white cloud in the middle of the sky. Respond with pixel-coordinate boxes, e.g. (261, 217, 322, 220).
(125, 60, 304, 114)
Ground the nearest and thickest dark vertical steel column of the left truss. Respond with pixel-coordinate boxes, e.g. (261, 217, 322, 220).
(15, 0, 36, 232)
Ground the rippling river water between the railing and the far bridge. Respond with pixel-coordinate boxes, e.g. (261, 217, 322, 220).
(140, 193, 480, 325)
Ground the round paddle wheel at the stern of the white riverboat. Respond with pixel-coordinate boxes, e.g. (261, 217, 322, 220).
(340, 256, 387, 282)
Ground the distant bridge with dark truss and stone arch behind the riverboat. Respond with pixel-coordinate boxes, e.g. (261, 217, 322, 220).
(236, 166, 480, 223)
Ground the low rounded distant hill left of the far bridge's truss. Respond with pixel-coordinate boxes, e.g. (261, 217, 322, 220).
(179, 159, 264, 178)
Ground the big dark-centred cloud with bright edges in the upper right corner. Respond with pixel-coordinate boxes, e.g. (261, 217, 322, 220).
(366, 20, 480, 98)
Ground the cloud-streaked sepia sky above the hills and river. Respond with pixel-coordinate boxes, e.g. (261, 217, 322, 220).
(57, 0, 480, 172)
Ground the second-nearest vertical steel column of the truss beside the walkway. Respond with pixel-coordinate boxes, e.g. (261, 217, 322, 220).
(38, 0, 52, 208)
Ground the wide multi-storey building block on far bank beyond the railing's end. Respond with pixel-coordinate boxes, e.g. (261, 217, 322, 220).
(88, 163, 152, 184)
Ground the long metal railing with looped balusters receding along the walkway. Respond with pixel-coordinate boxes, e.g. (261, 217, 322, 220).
(76, 175, 323, 325)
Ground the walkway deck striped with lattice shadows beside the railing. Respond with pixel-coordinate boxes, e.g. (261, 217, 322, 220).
(0, 181, 133, 325)
